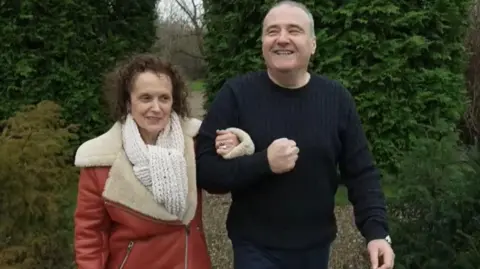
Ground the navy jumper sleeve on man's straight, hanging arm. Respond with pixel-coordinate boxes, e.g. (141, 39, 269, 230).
(339, 90, 388, 242)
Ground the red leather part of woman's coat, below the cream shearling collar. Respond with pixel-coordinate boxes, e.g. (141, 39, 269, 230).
(75, 168, 211, 269)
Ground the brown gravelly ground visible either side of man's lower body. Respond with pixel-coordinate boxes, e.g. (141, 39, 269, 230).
(203, 194, 369, 269)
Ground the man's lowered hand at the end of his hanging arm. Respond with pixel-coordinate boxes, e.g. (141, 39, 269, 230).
(367, 239, 395, 269)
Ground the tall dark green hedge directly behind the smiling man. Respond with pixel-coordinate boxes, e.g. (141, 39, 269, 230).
(205, 0, 470, 172)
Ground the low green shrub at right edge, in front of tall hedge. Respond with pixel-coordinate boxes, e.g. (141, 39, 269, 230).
(388, 126, 480, 269)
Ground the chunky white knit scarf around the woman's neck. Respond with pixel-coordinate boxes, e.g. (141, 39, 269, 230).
(122, 112, 188, 219)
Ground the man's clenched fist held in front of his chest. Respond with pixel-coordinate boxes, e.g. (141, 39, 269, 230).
(267, 138, 299, 174)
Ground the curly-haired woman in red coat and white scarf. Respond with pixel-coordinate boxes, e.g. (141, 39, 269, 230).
(75, 54, 253, 269)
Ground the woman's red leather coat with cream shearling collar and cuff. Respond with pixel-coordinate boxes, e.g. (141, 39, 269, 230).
(74, 119, 254, 269)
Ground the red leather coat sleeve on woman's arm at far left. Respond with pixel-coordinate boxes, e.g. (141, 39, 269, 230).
(75, 168, 111, 269)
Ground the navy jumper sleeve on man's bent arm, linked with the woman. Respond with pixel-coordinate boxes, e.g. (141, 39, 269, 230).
(196, 82, 272, 193)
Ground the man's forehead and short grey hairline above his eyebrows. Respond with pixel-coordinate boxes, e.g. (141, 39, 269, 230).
(263, 5, 309, 27)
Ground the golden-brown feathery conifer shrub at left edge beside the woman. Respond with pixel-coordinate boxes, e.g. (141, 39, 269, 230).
(0, 101, 77, 269)
